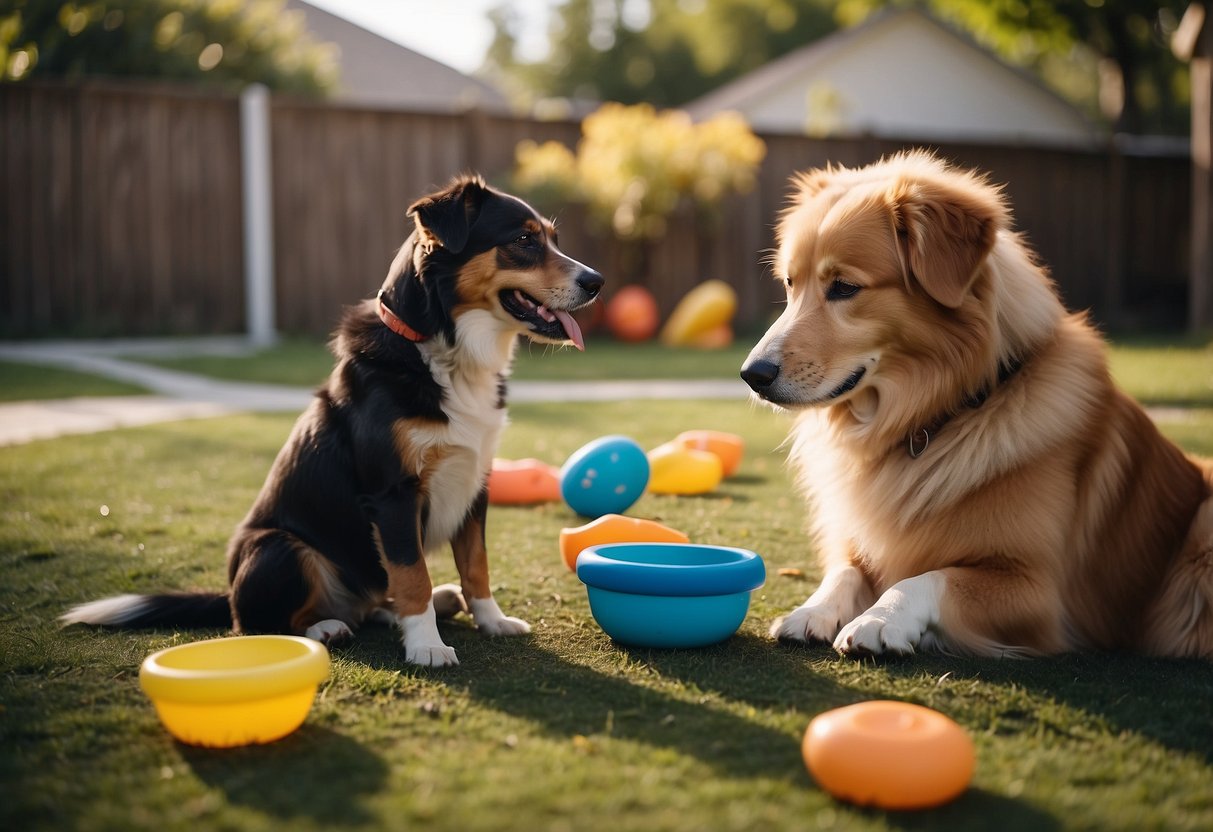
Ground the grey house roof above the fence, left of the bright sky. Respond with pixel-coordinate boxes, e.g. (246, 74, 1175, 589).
(286, 0, 508, 112)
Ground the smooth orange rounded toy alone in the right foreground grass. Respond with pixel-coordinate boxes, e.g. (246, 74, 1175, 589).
(801, 701, 976, 809)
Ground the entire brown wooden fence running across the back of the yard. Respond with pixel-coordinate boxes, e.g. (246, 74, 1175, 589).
(0, 77, 1190, 338)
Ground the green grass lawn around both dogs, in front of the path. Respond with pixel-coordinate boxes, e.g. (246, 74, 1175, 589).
(0, 401, 1213, 832)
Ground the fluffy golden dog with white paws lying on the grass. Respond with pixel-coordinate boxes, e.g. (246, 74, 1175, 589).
(741, 152, 1213, 657)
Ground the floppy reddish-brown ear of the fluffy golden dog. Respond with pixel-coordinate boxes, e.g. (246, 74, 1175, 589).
(889, 175, 1007, 309)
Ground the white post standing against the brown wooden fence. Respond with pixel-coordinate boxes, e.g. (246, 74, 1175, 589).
(240, 84, 278, 347)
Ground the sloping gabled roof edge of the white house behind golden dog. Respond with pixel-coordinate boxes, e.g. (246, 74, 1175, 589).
(684, 8, 1095, 144)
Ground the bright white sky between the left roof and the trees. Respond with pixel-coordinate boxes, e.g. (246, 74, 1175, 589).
(307, 0, 548, 73)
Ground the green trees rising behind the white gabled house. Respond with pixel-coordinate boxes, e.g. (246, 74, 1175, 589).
(486, 0, 1188, 132)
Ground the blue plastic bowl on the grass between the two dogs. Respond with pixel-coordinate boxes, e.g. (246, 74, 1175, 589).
(577, 543, 767, 648)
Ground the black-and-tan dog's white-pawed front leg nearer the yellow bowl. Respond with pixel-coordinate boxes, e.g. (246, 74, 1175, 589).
(371, 478, 459, 667)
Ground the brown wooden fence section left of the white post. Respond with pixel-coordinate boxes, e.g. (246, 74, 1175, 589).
(0, 84, 244, 337)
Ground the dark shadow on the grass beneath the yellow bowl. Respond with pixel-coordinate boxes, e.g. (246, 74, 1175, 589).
(181, 724, 388, 828)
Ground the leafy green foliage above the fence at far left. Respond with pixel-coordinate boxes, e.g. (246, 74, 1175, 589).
(0, 0, 337, 95)
